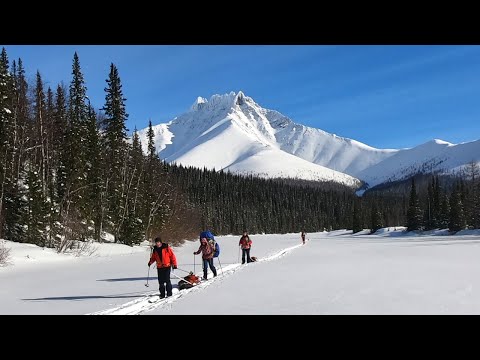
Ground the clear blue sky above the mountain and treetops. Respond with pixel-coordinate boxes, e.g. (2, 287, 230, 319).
(0, 45, 480, 148)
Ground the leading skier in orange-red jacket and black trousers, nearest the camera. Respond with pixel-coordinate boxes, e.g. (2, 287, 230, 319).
(148, 236, 177, 299)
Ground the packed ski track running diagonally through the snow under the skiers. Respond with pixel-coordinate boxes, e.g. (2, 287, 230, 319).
(86, 244, 303, 315)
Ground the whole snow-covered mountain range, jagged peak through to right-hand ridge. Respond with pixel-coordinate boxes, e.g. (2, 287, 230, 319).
(135, 91, 480, 187)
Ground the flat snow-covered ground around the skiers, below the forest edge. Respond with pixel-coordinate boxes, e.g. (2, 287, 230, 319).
(0, 227, 480, 315)
